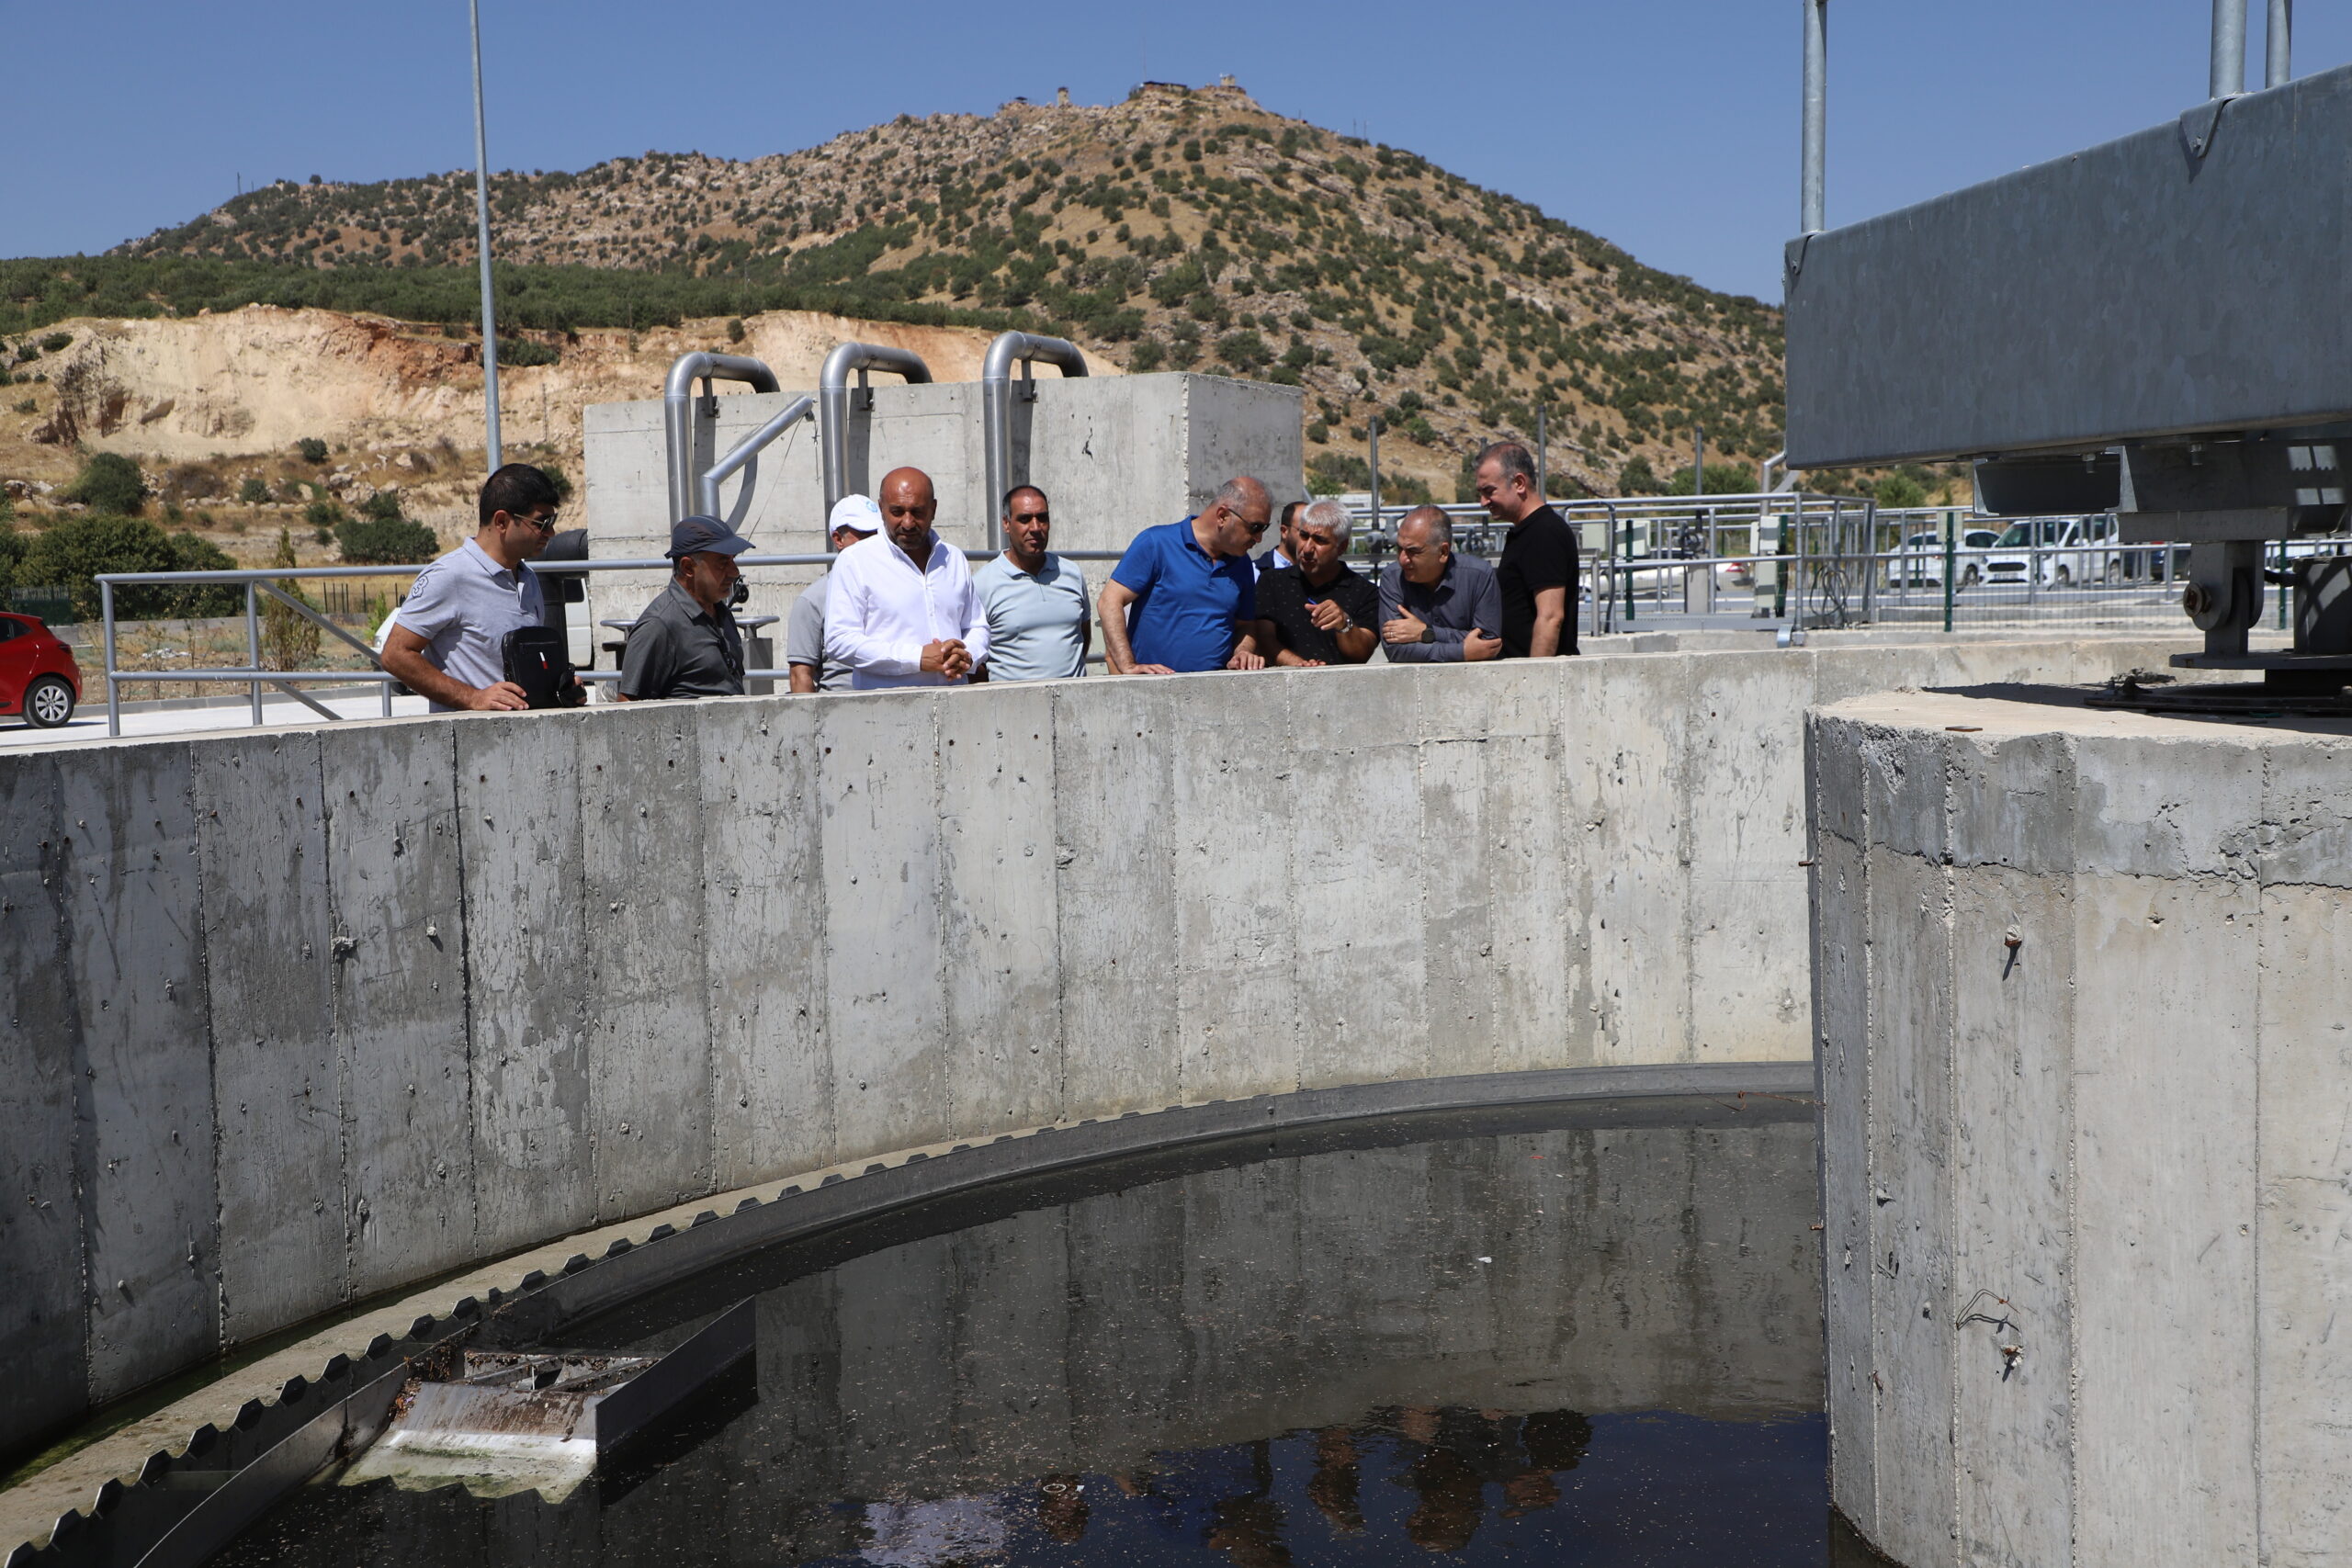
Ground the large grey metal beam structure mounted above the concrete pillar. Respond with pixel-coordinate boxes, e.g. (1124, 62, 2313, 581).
(1785, 0, 2352, 691)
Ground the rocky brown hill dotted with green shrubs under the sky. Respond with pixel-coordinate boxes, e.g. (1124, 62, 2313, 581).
(120, 85, 1781, 496)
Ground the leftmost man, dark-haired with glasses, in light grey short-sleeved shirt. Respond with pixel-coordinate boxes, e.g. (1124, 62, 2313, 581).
(381, 463, 579, 712)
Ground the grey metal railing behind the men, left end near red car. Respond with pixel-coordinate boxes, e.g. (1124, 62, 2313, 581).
(94, 550, 1143, 736)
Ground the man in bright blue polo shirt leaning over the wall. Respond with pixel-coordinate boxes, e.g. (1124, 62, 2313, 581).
(1096, 475, 1275, 674)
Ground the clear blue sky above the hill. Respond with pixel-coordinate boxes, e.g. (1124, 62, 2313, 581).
(0, 0, 2352, 299)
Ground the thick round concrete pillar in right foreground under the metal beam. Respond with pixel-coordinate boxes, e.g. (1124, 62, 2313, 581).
(1811, 696, 2352, 1568)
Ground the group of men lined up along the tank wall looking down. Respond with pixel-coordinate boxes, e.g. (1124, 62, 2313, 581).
(383, 442, 1578, 710)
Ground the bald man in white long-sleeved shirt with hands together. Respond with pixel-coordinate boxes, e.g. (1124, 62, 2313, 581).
(826, 468, 988, 691)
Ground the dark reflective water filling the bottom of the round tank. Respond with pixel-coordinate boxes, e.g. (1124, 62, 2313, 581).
(219, 1100, 1832, 1568)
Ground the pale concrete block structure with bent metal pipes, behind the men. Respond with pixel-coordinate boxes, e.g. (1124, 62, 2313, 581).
(585, 369, 1306, 639)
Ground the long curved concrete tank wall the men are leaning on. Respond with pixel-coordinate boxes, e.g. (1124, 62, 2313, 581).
(0, 639, 2201, 1448)
